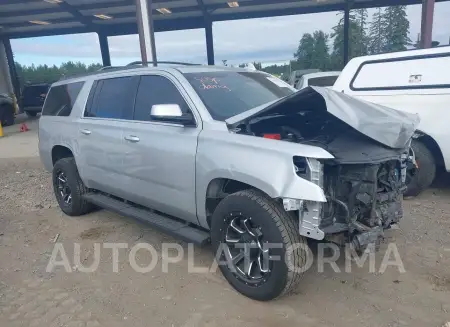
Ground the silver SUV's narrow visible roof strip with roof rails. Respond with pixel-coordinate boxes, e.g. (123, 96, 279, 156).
(54, 63, 264, 85)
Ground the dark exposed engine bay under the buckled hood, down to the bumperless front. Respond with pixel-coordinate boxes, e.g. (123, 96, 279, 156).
(239, 111, 409, 249)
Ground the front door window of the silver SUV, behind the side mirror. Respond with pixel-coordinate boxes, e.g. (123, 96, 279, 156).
(133, 75, 190, 121)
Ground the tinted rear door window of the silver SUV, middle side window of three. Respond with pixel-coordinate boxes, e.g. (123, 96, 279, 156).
(84, 76, 139, 119)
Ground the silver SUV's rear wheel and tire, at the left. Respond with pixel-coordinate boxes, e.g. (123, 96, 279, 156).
(53, 157, 93, 216)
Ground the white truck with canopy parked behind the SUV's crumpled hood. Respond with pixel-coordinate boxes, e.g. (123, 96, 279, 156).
(333, 46, 450, 195)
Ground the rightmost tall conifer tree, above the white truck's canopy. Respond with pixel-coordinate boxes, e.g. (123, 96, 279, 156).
(382, 6, 411, 52)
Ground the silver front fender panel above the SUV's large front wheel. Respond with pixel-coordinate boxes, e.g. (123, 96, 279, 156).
(196, 131, 334, 227)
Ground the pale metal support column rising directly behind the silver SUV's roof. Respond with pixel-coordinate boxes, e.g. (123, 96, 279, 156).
(136, 0, 157, 66)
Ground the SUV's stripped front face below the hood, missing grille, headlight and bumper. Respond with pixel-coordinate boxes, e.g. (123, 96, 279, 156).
(294, 152, 408, 250)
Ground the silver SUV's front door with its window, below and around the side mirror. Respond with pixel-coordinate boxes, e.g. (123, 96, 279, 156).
(123, 73, 201, 223)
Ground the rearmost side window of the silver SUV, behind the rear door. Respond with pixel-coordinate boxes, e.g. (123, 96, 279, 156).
(42, 82, 84, 116)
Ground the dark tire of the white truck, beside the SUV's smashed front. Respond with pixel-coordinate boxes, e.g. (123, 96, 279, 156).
(405, 140, 436, 196)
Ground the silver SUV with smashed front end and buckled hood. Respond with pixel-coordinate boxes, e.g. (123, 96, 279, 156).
(39, 65, 418, 300)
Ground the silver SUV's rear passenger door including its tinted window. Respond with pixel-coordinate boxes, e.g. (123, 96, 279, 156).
(77, 76, 139, 197)
